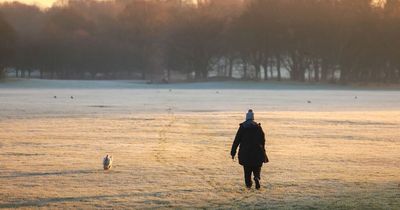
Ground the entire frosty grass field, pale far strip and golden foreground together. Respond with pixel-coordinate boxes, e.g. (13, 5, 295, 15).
(0, 80, 400, 209)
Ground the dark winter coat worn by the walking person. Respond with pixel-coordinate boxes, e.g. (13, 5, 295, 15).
(231, 120, 265, 167)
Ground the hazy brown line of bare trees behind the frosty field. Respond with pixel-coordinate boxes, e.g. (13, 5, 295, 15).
(0, 0, 400, 83)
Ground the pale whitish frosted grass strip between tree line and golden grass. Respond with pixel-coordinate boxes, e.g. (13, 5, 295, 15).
(0, 80, 400, 118)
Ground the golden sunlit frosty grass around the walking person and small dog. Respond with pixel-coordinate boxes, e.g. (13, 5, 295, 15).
(0, 111, 400, 209)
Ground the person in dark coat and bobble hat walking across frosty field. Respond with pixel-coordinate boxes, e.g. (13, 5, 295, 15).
(231, 109, 268, 189)
